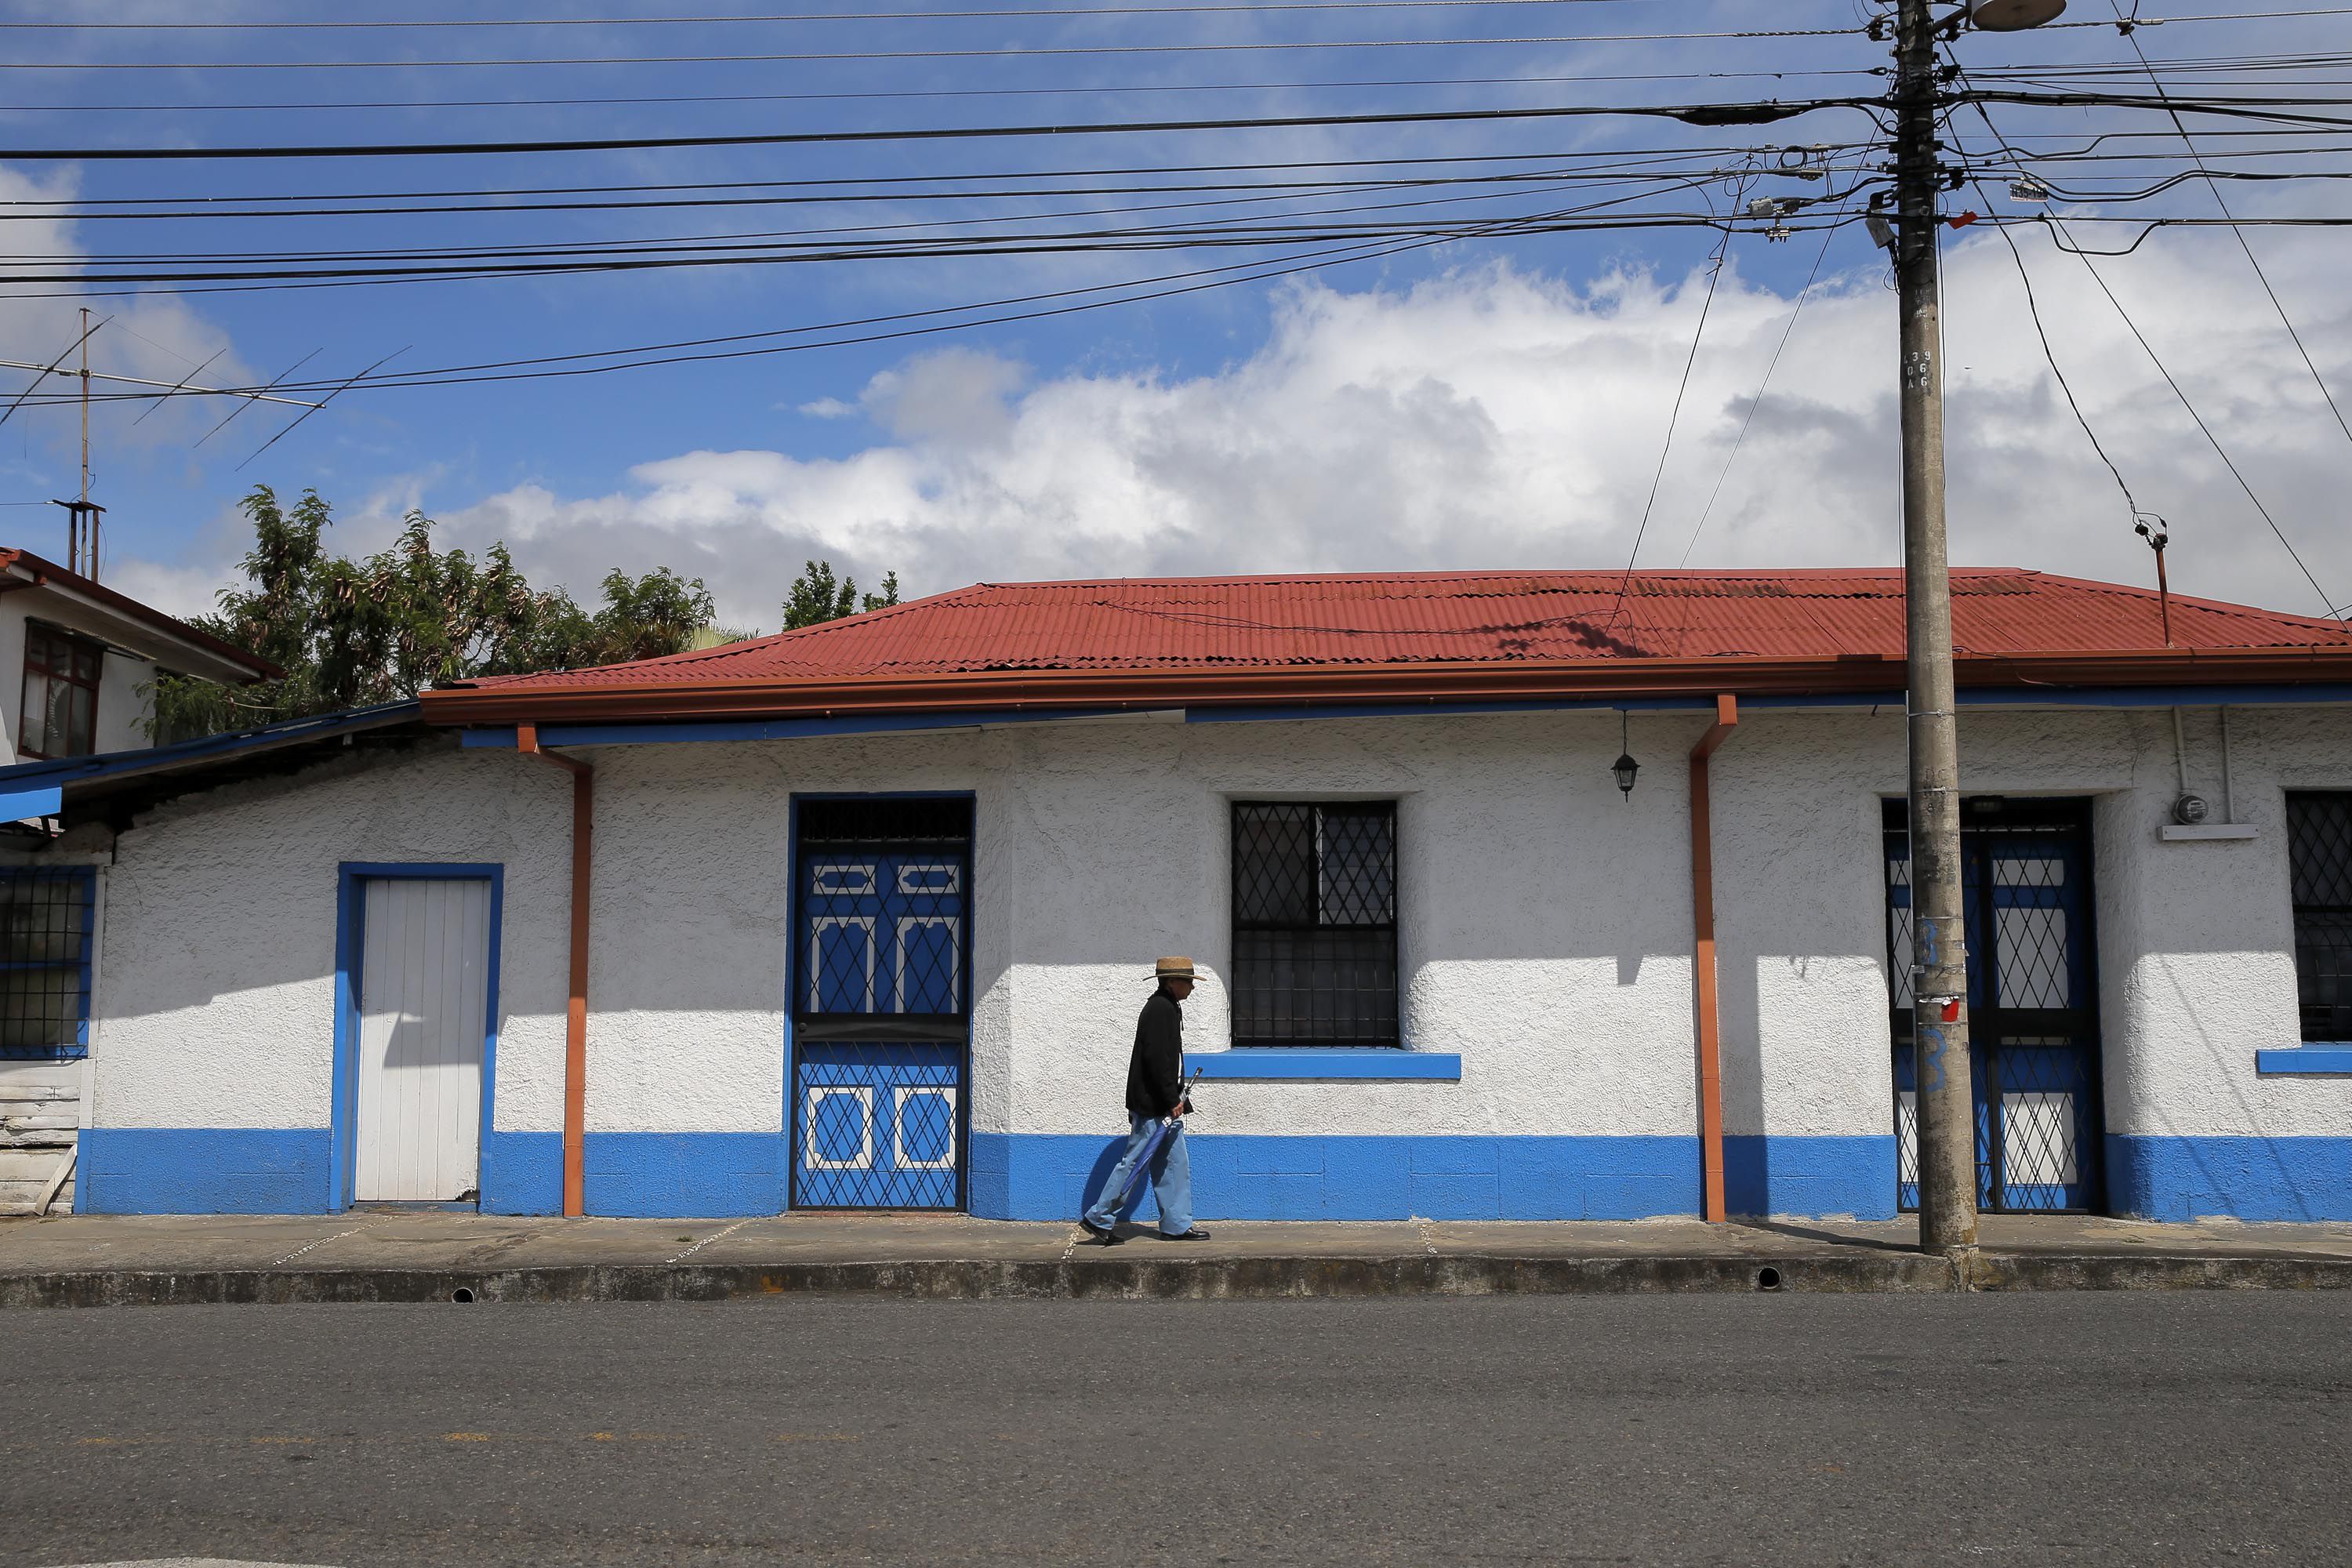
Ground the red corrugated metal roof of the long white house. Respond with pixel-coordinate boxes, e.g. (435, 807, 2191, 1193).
(454, 569, 2352, 699)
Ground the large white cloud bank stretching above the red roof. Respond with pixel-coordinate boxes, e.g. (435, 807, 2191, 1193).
(129, 222, 2352, 626)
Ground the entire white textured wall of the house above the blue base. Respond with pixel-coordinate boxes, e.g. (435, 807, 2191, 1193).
(73, 708, 2352, 1133)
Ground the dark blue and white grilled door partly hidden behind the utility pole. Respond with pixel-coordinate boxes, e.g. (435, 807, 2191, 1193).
(1886, 797, 2105, 1213)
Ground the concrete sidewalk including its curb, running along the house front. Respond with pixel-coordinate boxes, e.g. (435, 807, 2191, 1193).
(0, 1210, 2352, 1307)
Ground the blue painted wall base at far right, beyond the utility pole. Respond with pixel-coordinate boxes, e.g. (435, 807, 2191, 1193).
(2107, 1133, 2352, 1220)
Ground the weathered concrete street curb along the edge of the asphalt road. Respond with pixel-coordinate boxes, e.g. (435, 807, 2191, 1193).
(0, 1248, 2352, 1309)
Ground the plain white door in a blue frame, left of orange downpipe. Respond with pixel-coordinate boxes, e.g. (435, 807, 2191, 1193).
(350, 877, 489, 1203)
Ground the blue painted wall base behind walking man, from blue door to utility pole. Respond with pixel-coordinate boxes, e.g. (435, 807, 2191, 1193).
(971, 1133, 1896, 1220)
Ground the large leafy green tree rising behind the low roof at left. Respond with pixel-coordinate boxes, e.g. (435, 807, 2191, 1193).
(151, 485, 713, 741)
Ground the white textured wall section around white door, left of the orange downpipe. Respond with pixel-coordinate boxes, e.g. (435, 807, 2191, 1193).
(92, 741, 572, 1128)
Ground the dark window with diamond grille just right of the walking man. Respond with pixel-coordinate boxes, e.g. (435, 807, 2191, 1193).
(1232, 801, 1399, 1046)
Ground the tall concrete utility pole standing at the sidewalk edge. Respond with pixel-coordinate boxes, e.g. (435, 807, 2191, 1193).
(1893, 0, 1976, 1253)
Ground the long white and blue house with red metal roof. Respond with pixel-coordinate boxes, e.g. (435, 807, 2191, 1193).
(0, 572, 2352, 1220)
